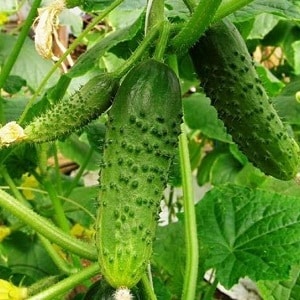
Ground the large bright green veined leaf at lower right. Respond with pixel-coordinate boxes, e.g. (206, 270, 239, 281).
(197, 184, 300, 288)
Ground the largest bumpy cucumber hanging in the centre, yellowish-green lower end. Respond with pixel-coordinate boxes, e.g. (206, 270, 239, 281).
(96, 59, 182, 288)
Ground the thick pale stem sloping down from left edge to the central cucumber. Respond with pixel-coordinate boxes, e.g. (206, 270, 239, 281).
(0, 190, 97, 260)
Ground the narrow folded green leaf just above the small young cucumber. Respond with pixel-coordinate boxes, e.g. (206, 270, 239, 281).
(67, 18, 142, 78)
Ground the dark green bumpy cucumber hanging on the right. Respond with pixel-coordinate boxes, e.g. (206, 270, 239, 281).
(190, 20, 299, 180)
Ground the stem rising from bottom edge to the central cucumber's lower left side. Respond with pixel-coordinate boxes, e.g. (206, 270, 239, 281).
(28, 263, 99, 300)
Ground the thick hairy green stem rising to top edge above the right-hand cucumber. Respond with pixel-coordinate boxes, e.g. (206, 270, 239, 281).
(171, 0, 222, 53)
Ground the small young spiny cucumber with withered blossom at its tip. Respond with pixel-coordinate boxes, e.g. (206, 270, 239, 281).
(24, 74, 118, 143)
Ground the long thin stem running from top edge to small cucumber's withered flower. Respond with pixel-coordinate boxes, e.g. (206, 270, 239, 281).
(19, 0, 124, 124)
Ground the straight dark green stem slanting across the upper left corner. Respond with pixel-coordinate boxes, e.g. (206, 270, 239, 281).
(0, 0, 41, 123)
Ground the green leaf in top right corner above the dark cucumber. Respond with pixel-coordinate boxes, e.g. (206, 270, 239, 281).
(233, 0, 300, 22)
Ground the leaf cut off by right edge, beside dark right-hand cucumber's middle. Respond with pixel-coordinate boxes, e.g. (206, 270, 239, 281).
(273, 79, 300, 125)
